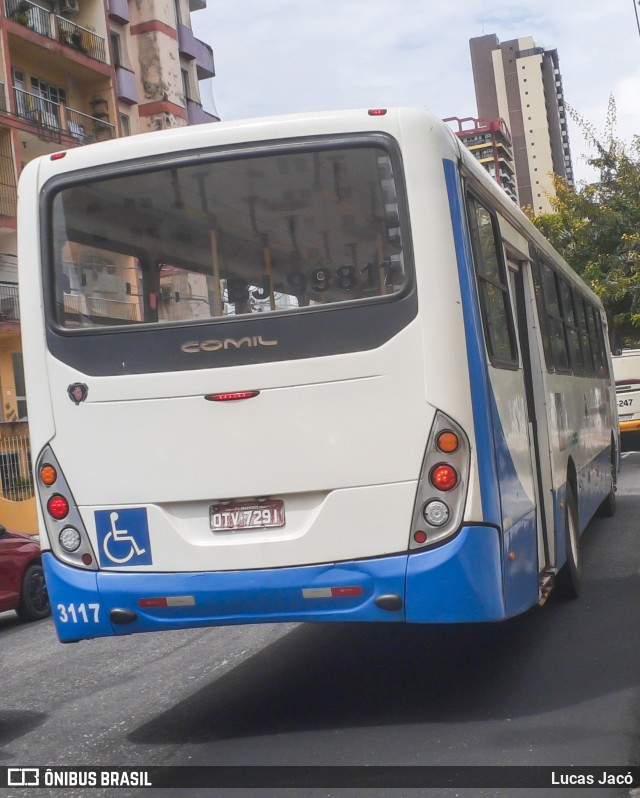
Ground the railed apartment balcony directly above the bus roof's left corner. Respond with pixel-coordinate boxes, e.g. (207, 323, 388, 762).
(13, 88, 116, 144)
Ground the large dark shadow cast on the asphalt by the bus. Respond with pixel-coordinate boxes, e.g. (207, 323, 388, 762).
(129, 496, 640, 744)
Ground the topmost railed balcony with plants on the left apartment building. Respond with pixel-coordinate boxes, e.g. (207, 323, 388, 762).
(4, 0, 108, 64)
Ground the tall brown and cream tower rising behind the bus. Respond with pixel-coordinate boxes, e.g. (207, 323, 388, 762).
(469, 34, 573, 214)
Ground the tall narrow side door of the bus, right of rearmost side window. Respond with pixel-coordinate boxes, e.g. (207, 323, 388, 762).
(507, 256, 556, 575)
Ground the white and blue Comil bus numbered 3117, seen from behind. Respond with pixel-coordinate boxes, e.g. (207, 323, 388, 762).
(19, 109, 619, 642)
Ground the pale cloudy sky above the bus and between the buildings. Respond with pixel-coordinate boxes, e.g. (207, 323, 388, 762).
(191, 0, 640, 181)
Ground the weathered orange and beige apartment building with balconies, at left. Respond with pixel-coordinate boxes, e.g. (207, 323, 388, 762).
(0, 0, 217, 531)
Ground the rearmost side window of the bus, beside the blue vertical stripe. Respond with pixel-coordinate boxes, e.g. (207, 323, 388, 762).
(468, 197, 518, 369)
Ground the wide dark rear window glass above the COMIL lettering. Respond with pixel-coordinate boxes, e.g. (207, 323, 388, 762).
(52, 145, 407, 329)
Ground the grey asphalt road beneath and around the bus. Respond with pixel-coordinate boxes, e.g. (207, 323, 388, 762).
(0, 453, 640, 798)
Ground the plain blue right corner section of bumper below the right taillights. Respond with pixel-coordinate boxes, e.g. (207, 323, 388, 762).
(406, 526, 507, 623)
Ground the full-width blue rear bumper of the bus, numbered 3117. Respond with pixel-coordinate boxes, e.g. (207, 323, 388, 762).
(42, 527, 505, 642)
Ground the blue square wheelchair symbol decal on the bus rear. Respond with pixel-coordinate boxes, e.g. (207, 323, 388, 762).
(95, 507, 152, 568)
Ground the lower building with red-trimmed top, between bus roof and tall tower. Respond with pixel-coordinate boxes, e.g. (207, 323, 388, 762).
(444, 116, 518, 203)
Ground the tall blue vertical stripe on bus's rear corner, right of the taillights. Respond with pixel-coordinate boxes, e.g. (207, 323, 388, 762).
(443, 159, 502, 526)
